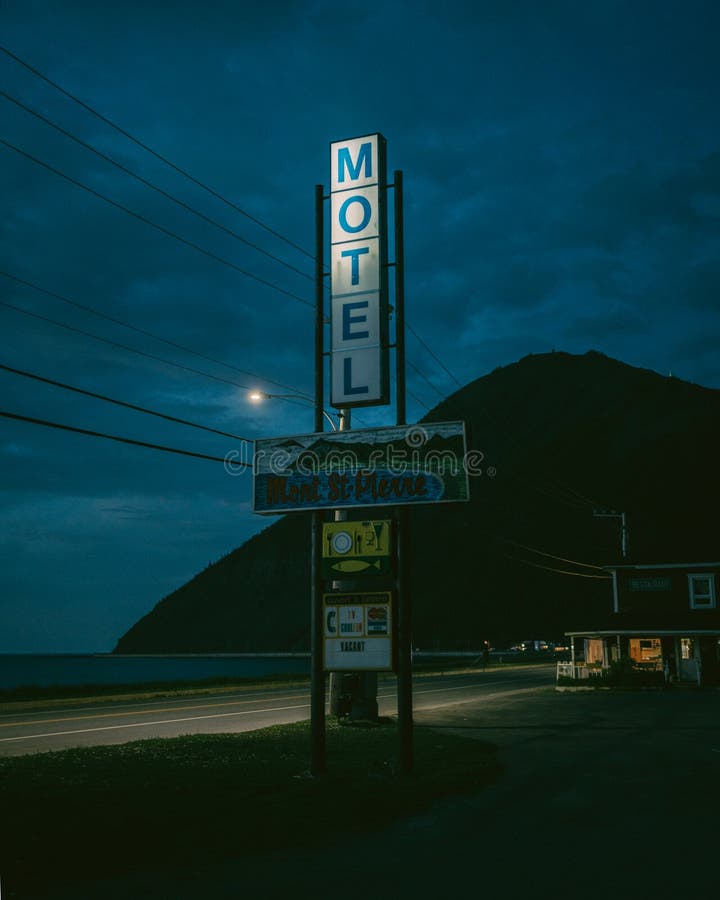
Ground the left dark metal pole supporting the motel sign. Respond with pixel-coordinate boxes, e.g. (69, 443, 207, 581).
(310, 184, 326, 775)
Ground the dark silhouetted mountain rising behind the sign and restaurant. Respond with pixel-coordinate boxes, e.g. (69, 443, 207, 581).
(116, 352, 720, 653)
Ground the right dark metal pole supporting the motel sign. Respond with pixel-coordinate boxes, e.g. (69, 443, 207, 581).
(394, 171, 413, 775)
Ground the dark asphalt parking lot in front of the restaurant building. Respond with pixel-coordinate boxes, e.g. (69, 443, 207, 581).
(21, 664, 720, 900)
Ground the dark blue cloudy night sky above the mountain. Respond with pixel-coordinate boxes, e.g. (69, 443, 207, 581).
(0, 0, 720, 652)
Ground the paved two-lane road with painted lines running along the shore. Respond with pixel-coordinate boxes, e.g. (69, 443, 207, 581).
(0, 667, 552, 756)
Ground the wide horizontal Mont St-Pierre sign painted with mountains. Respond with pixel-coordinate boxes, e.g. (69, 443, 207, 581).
(253, 422, 472, 515)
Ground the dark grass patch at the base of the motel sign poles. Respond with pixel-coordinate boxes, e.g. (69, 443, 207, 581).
(0, 720, 500, 898)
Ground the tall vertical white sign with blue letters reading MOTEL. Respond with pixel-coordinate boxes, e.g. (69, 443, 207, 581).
(330, 134, 390, 408)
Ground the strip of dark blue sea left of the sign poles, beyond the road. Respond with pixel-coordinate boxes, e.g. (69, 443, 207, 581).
(0, 653, 310, 690)
